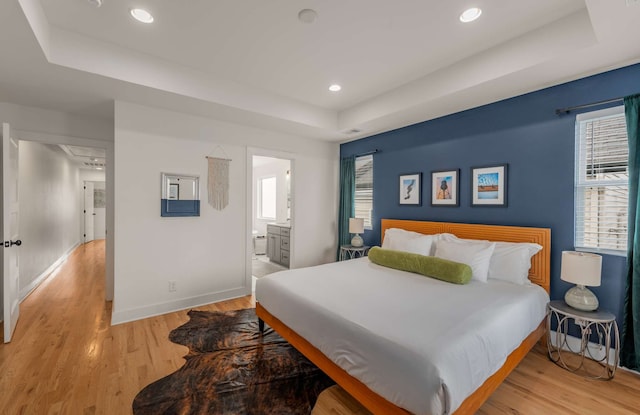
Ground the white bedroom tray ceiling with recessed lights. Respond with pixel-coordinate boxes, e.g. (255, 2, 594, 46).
(0, 0, 640, 142)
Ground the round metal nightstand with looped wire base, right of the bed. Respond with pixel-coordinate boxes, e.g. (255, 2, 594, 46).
(547, 301, 620, 379)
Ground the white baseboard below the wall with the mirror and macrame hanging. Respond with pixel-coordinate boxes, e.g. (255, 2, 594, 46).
(111, 287, 251, 326)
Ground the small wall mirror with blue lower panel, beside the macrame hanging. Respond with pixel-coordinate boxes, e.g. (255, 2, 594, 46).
(160, 173, 200, 216)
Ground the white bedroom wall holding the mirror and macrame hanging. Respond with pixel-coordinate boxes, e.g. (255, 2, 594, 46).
(112, 102, 339, 323)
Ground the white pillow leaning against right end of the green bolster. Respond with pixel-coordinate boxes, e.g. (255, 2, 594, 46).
(435, 235, 496, 282)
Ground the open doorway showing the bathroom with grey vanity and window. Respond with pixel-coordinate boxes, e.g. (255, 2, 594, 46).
(251, 155, 292, 283)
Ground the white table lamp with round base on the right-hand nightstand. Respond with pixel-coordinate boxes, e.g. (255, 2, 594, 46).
(560, 251, 602, 311)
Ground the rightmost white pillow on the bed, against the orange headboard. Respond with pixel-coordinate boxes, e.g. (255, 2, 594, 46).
(489, 242, 542, 285)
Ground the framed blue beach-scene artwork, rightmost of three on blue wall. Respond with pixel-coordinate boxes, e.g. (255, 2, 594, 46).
(471, 164, 508, 206)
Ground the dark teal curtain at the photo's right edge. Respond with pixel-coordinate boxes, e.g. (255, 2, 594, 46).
(620, 94, 640, 370)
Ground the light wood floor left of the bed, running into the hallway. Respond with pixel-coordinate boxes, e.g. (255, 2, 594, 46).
(0, 240, 252, 415)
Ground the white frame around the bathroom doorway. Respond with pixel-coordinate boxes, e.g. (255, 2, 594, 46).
(244, 147, 296, 295)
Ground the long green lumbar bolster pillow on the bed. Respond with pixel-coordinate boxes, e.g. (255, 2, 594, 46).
(369, 246, 471, 284)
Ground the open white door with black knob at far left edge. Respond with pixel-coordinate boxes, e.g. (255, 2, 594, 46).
(0, 123, 22, 343)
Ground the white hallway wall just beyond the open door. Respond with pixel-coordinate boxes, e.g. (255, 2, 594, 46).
(18, 141, 81, 298)
